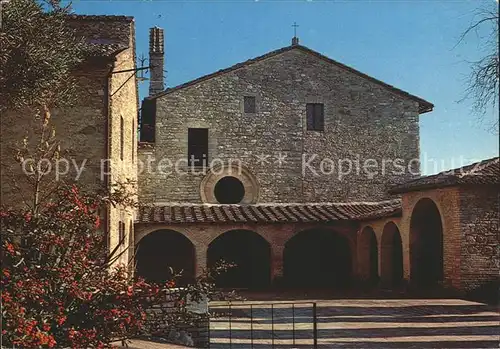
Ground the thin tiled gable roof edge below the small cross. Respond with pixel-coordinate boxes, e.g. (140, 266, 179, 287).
(146, 45, 434, 113)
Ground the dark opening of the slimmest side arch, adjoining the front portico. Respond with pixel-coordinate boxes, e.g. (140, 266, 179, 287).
(358, 227, 379, 284)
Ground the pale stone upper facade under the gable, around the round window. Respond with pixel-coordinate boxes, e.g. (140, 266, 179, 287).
(139, 49, 419, 203)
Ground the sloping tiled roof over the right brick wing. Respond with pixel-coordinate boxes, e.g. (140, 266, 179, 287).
(389, 157, 500, 194)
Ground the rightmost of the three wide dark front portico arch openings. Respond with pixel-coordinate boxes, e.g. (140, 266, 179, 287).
(283, 229, 352, 288)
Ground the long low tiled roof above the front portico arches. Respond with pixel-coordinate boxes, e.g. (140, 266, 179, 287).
(137, 200, 401, 224)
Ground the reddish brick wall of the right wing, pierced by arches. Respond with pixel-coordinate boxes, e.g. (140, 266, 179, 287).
(357, 186, 500, 292)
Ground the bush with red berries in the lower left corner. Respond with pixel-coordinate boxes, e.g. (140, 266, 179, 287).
(0, 186, 160, 348)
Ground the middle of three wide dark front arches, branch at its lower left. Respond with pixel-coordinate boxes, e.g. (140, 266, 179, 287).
(207, 230, 271, 289)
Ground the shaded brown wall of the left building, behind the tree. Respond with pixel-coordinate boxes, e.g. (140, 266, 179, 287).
(0, 60, 111, 206)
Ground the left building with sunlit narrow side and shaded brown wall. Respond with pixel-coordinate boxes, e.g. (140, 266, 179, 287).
(1, 15, 139, 263)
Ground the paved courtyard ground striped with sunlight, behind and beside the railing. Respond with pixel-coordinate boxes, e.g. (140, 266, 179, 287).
(210, 299, 500, 349)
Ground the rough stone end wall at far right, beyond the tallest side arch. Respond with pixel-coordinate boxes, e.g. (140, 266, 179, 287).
(460, 186, 500, 290)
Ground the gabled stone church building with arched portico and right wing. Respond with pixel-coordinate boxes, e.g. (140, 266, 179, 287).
(135, 28, 499, 291)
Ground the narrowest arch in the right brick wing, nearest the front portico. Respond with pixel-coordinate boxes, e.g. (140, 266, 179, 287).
(357, 225, 379, 283)
